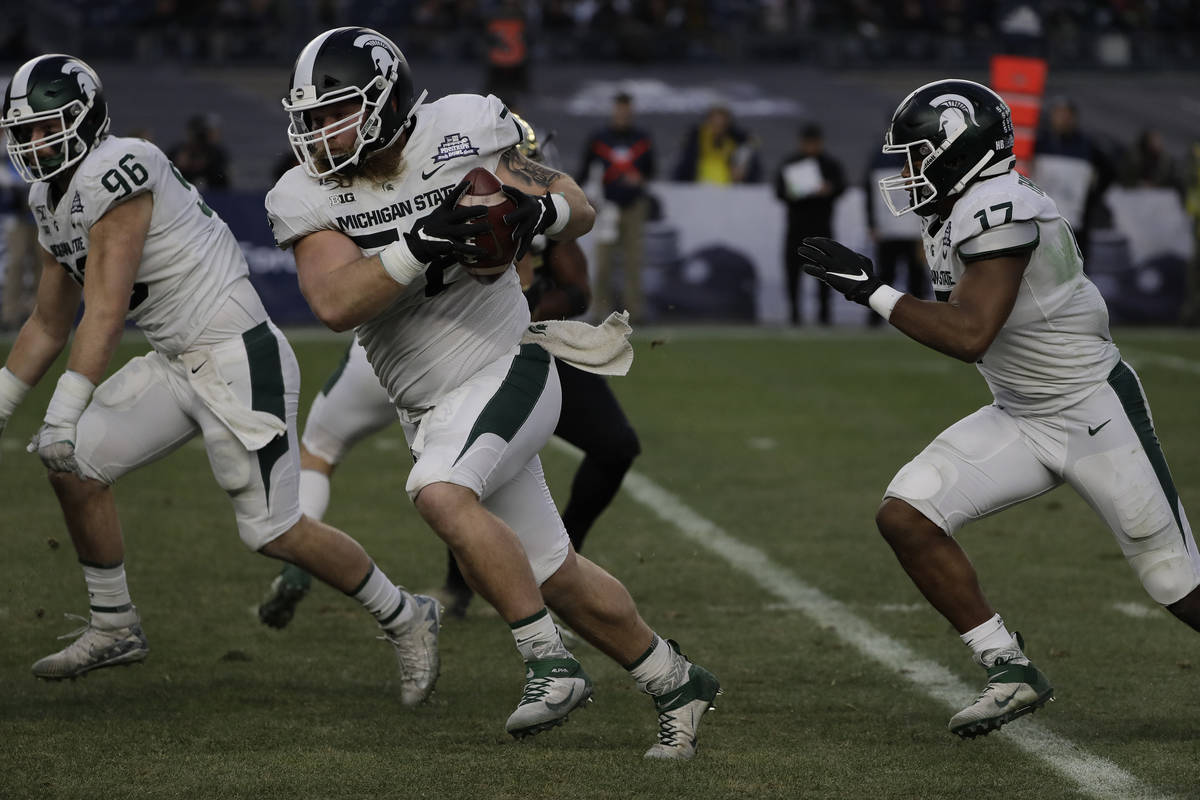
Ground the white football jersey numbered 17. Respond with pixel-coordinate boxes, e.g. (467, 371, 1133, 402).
(924, 172, 1121, 414)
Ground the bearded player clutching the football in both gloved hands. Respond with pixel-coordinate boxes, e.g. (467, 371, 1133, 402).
(266, 28, 719, 758)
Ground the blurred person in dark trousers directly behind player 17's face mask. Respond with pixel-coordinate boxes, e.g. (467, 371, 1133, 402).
(863, 149, 929, 327)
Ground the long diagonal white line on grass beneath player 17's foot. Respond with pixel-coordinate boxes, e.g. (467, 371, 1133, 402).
(551, 438, 1163, 800)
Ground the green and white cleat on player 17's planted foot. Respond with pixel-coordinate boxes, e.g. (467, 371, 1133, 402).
(949, 633, 1054, 739)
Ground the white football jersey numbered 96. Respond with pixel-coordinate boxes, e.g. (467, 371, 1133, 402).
(29, 137, 248, 356)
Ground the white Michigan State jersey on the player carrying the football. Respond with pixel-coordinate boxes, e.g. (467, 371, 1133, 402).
(266, 95, 529, 410)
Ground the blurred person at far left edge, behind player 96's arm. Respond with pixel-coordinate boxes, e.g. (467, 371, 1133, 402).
(0, 151, 42, 331)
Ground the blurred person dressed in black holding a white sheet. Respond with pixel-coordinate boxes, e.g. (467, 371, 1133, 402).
(775, 124, 846, 325)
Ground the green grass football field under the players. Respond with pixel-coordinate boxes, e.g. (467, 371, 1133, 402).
(0, 329, 1200, 800)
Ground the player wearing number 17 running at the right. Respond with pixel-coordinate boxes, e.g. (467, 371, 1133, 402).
(800, 80, 1200, 738)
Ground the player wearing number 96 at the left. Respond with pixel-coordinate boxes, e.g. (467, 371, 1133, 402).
(0, 55, 439, 705)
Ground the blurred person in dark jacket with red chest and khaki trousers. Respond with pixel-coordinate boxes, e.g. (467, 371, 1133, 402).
(577, 92, 654, 320)
